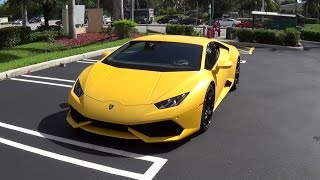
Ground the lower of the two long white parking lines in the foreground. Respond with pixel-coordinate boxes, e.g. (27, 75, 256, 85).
(0, 137, 143, 179)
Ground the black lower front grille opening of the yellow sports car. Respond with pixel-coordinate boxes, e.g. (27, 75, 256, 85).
(70, 106, 183, 137)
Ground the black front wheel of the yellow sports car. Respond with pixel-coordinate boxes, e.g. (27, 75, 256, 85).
(200, 84, 215, 133)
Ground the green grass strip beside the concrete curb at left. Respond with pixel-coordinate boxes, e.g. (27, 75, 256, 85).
(0, 39, 130, 72)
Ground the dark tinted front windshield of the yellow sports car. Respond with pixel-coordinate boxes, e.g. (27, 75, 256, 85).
(102, 41, 202, 72)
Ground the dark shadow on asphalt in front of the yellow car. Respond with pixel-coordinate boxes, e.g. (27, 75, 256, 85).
(38, 110, 199, 156)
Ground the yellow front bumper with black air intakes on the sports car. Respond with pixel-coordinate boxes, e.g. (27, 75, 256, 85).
(67, 88, 202, 143)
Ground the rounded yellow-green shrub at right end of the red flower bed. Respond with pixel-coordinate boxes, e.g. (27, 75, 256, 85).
(112, 20, 136, 39)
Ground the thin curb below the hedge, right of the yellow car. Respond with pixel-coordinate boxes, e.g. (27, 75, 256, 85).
(219, 39, 304, 51)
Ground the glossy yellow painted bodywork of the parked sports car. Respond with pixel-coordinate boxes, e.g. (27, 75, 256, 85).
(67, 35, 239, 142)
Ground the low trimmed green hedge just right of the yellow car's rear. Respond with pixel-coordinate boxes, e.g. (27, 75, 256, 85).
(236, 28, 300, 46)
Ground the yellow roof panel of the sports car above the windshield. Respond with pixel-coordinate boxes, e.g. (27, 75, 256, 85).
(133, 35, 212, 46)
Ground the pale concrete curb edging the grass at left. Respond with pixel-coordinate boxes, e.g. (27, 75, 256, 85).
(0, 46, 120, 81)
